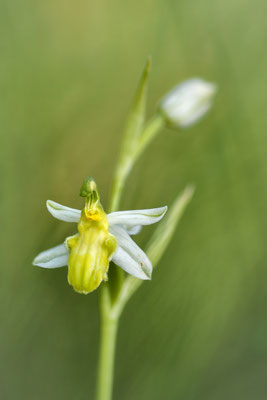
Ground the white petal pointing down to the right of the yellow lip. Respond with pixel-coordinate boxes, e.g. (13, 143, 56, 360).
(109, 226, 152, 280)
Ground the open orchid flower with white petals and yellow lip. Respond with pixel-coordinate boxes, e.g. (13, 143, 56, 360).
(33, 177, 167, 294)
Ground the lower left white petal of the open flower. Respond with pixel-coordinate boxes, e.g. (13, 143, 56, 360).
(33, 243, 69, 268)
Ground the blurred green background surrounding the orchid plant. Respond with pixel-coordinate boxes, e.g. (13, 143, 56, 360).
(0, 0, 267, 400)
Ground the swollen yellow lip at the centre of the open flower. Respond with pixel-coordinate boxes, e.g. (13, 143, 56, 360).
(66, 180, 117, 294)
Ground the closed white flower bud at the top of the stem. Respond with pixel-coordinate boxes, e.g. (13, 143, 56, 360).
(159, 78, 216, 128)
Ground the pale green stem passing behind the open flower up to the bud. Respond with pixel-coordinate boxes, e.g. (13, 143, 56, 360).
(96, 113, 164, 400)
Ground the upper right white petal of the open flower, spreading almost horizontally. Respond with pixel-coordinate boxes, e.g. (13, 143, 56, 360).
(108, 206, 168, 231)
